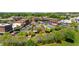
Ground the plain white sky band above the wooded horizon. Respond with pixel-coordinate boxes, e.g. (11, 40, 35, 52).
(0, 0, 79, 12)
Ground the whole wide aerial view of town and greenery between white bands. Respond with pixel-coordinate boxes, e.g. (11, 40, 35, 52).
(0, 12, 79, 46)
